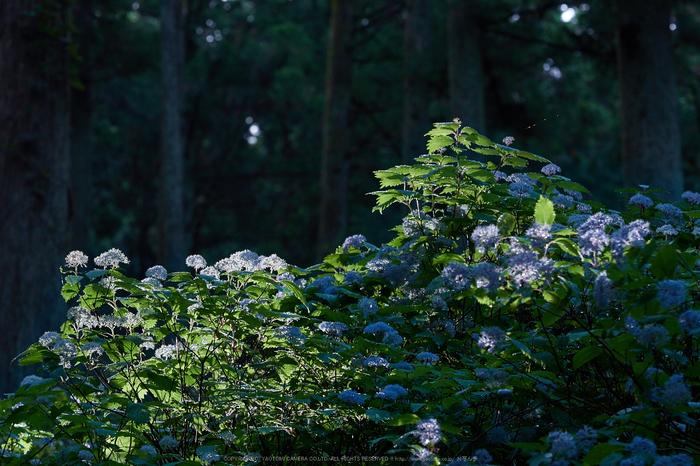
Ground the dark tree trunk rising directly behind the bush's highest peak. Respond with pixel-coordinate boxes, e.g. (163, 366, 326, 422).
(447, 0, 486, 134)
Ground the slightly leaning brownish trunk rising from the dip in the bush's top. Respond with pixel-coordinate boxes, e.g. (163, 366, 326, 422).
(317, 0, 354, 259)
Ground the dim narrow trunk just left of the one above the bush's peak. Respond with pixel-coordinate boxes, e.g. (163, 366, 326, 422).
(402, 0, 430, 163)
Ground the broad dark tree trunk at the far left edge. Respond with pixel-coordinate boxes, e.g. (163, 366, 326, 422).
(0, 0, 71, 393)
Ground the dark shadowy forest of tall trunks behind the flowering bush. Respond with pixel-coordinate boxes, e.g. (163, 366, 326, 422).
(0, 0, 700, 392)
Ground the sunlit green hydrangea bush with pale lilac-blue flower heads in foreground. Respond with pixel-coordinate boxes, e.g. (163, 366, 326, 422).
(0, 120, 700, 466)
